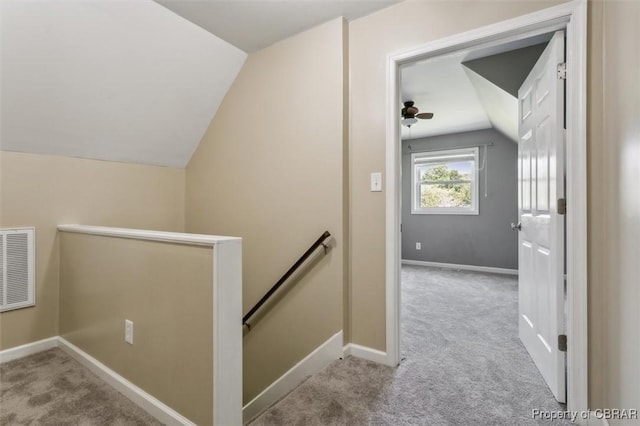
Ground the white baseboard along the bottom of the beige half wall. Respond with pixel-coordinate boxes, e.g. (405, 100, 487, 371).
(57, 337, 195, 426)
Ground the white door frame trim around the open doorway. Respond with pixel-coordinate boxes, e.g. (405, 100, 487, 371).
(385, 0, 588, 412)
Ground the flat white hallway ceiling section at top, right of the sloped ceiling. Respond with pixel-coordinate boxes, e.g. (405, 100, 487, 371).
(155, 0, 400, 52)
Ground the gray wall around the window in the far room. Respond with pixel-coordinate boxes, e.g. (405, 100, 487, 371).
(402, 129, 518, 269)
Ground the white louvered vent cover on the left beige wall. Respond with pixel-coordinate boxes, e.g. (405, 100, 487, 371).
(0, 228, 35, 312)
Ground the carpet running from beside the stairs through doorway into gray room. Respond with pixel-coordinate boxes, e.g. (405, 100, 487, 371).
(251, 266, 570, 426)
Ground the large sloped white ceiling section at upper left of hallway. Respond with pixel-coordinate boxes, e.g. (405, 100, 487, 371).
(0, 0, 246, 167)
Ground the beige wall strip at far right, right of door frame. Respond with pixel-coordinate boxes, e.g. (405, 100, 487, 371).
(589, 1, 640, 412)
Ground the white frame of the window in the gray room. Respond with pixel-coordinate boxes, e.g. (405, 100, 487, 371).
(411, 147, 480, 215)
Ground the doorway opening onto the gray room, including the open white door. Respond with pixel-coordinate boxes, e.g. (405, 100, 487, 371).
(400, 31, 566, 402)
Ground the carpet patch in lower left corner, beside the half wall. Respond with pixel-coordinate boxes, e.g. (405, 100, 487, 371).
(0, 348, 161, 426)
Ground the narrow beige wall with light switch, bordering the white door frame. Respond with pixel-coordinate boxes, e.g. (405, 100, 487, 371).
(349, 1, 564, 351)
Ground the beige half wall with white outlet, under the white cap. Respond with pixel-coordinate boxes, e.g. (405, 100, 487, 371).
(60, 233, 213, 425)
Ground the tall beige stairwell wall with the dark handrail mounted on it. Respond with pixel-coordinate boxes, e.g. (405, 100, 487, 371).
(186, 19, 344, 403)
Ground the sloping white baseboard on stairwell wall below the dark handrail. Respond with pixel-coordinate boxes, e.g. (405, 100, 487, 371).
(242, 330, 342, 424)
